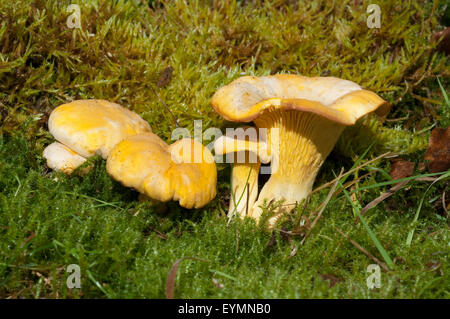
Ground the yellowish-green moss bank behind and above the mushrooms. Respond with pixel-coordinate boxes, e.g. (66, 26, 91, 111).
(0, 0, 449, 139)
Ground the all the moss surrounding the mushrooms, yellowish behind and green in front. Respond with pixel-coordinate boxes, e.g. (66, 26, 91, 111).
(0, 0, 450, 298)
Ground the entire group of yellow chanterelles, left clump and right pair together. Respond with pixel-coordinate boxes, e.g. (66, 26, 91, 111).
(43, 74, 389, 221)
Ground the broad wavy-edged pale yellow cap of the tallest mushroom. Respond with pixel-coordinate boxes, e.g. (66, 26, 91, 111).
(211, 74, 389, 125)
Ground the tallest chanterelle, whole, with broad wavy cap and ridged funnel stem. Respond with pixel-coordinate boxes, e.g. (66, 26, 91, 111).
(211, 74, 389, 227)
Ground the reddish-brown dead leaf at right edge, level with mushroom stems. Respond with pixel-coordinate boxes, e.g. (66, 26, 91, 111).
(424, 127, 450, 173)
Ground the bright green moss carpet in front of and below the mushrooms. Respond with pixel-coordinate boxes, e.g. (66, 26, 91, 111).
(0, 137, 450, 298)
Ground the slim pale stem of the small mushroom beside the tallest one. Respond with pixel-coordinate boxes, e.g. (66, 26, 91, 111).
(228, 161, 261, 218)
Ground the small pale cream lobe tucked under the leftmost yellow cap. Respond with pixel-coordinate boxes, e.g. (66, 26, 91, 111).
(43, 142, 86, 174)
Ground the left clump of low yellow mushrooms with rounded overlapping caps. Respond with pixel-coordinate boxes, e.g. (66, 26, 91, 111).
(43, 100, 217, 208)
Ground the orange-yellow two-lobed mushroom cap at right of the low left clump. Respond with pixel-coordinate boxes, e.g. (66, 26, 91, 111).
(106, 133, 217, 208)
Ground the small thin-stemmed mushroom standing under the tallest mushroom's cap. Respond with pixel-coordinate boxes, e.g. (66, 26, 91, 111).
(214, 127, 270, 218)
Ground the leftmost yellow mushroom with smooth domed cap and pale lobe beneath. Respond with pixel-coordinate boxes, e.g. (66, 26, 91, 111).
(43, 100, 152, 174)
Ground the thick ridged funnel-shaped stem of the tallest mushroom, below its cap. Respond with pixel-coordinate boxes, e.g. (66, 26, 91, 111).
(251, 109, 345, 227)
